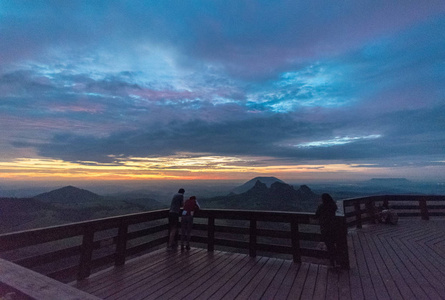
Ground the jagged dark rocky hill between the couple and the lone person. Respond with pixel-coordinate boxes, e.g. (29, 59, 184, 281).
(199, 180, 319, 211)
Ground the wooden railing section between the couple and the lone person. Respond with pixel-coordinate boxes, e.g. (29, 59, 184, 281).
(192, 209, 349, 268)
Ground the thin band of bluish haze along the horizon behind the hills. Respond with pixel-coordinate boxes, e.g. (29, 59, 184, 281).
(0, 177, 445, 202)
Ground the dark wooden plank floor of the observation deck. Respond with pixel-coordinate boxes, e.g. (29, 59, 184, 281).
(73, 219, 445, 300)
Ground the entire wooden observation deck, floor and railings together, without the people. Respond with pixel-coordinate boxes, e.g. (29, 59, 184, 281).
(0, 195, 445, 300)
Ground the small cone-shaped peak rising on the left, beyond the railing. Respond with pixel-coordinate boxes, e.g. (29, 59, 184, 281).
(33, 185, 103, 205)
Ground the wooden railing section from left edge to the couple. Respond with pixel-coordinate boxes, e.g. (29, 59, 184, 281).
(0, 210, 168, 282)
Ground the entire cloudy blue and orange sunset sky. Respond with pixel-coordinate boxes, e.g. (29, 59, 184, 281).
(0, 0, 445, 183)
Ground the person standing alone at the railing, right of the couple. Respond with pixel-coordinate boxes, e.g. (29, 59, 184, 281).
(315, 193, 337, 267)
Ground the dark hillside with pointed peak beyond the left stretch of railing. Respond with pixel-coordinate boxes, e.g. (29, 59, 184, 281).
(0, 186, 165, 234)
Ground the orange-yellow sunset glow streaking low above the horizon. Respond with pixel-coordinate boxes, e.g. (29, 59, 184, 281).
(0, 154, 388, 181)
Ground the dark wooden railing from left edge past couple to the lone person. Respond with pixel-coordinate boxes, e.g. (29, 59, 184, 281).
(0, 209, 349, 282)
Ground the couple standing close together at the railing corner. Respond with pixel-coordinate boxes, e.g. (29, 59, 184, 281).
(167, 189, 200, 250)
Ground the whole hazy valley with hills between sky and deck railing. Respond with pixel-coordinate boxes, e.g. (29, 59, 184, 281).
(0, 176, 445, 233)
